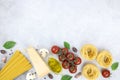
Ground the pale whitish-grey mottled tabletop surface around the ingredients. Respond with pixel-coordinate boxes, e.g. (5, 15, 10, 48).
(0, 0, 120, 80)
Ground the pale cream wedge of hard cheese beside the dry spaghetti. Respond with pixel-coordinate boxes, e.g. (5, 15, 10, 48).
(27, 47, 50, 77)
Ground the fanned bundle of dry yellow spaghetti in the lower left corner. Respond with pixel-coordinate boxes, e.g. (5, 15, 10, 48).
(0, 50, 32, 80)
